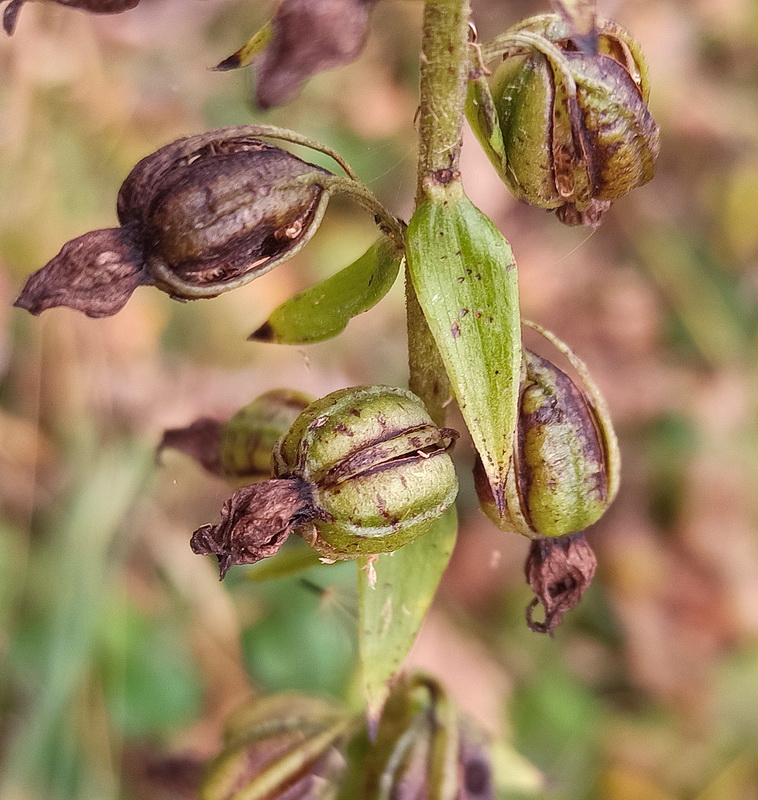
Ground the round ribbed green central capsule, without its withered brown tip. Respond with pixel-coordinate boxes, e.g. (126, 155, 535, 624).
(274, 386, 458, 555)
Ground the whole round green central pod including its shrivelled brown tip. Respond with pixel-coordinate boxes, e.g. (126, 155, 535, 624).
(191, 386, 458, 577)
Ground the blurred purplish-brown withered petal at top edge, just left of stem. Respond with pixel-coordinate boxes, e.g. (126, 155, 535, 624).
(256, 0, 375, 108)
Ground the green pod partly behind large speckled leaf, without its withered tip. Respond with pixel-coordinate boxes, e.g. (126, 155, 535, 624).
(475, 334, 619, 539)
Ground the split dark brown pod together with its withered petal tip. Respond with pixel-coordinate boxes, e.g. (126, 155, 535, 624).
(15, 128, 333, 317)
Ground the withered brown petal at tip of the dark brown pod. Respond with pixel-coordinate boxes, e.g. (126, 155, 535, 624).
(13, 228, 150, 317)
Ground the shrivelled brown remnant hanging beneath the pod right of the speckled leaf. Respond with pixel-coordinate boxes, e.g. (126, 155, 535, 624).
(524, 533, 597, 634)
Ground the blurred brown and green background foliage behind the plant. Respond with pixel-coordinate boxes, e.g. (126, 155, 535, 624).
(0, 0, 758, 800)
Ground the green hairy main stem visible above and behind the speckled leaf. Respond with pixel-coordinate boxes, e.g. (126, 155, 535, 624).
(405, 0, 469, 425)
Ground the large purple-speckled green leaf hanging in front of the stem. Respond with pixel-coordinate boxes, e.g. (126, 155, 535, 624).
(407, 191, 521, 508)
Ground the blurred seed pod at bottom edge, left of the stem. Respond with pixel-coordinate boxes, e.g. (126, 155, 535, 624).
(199, 692, 355, 800)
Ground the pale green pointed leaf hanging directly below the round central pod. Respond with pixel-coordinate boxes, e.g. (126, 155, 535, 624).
(358, 506, 458, 720)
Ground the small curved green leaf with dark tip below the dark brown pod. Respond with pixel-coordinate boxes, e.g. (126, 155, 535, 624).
(250, 236, 403, 344)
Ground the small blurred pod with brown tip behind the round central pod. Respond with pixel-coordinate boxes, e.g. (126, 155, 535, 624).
(158, 389, 313, 485)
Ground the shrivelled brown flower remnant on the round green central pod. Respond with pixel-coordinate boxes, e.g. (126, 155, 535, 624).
(190, 478, 313, 578)
